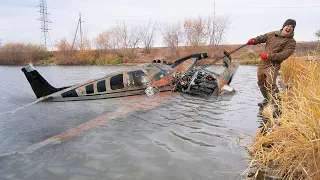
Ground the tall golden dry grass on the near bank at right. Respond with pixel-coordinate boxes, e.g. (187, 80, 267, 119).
(250, 58, 320, 179)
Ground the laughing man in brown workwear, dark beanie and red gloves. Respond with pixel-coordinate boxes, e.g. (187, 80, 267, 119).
(247, 19, 296, 107)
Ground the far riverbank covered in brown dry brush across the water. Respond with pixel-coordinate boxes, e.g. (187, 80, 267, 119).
(0, 42, 317, 66)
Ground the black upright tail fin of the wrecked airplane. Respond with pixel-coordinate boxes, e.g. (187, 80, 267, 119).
(21, 64, 67, 98)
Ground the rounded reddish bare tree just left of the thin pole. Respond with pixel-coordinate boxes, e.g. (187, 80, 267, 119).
(183, 17, 208, 47)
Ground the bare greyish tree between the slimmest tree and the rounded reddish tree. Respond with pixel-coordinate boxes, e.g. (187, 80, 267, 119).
(160, 22, 184, 59)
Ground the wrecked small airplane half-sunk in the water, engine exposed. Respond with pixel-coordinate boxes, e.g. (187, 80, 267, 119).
(21, 53, 238, 101)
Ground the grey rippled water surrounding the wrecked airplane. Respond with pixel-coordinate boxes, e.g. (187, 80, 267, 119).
(0, 66, 261, 180)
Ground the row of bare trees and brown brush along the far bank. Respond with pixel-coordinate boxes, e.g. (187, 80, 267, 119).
(0, 16, 230, 65)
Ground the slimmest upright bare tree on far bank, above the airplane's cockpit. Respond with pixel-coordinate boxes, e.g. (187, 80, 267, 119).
(141, 20, 156, 54)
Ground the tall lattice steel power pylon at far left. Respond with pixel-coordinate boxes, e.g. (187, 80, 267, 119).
(38, 0, 51, 48)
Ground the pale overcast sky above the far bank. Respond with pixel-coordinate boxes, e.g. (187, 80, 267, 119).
(0, 0, 320, 46)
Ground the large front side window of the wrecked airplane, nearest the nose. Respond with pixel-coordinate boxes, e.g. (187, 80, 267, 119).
(127, 70, 148, 87)
